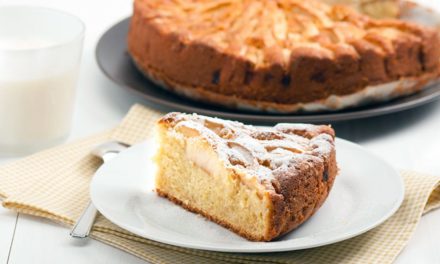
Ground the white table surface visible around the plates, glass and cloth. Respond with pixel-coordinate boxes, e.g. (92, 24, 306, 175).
(0, 0, 440, 263)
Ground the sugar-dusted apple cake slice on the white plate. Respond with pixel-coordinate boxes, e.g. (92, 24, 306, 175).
(155, 113, 337, 241)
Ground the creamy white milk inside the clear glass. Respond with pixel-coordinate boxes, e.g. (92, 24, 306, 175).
(0, 70, 77, 153)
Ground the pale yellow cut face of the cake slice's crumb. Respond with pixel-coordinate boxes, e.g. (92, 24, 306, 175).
(156, 125, 271, 240)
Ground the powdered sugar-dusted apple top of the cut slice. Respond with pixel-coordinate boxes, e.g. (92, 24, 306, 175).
(162, 113, 334, 183)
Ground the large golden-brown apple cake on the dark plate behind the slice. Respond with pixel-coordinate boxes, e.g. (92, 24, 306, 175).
(128, 0, 440, 113)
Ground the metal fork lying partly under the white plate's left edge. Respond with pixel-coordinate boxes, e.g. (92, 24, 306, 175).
(70, 141, 129, 238)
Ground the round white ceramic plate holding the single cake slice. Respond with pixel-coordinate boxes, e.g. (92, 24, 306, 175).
(91, 139, 404, 253)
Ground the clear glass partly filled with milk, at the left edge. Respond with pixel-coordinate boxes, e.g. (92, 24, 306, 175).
(0, 6, 85, 156)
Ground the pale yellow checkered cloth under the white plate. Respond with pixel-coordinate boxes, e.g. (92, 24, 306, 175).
(0, 105, 440, 263)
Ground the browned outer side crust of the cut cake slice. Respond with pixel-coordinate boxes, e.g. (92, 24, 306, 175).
(264, 126, 338, 238)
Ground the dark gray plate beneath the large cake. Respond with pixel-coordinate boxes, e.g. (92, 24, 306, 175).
(96, 18, 440, 123)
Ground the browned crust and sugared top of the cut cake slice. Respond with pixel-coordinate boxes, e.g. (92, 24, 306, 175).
(156, 113, 338, 241)
